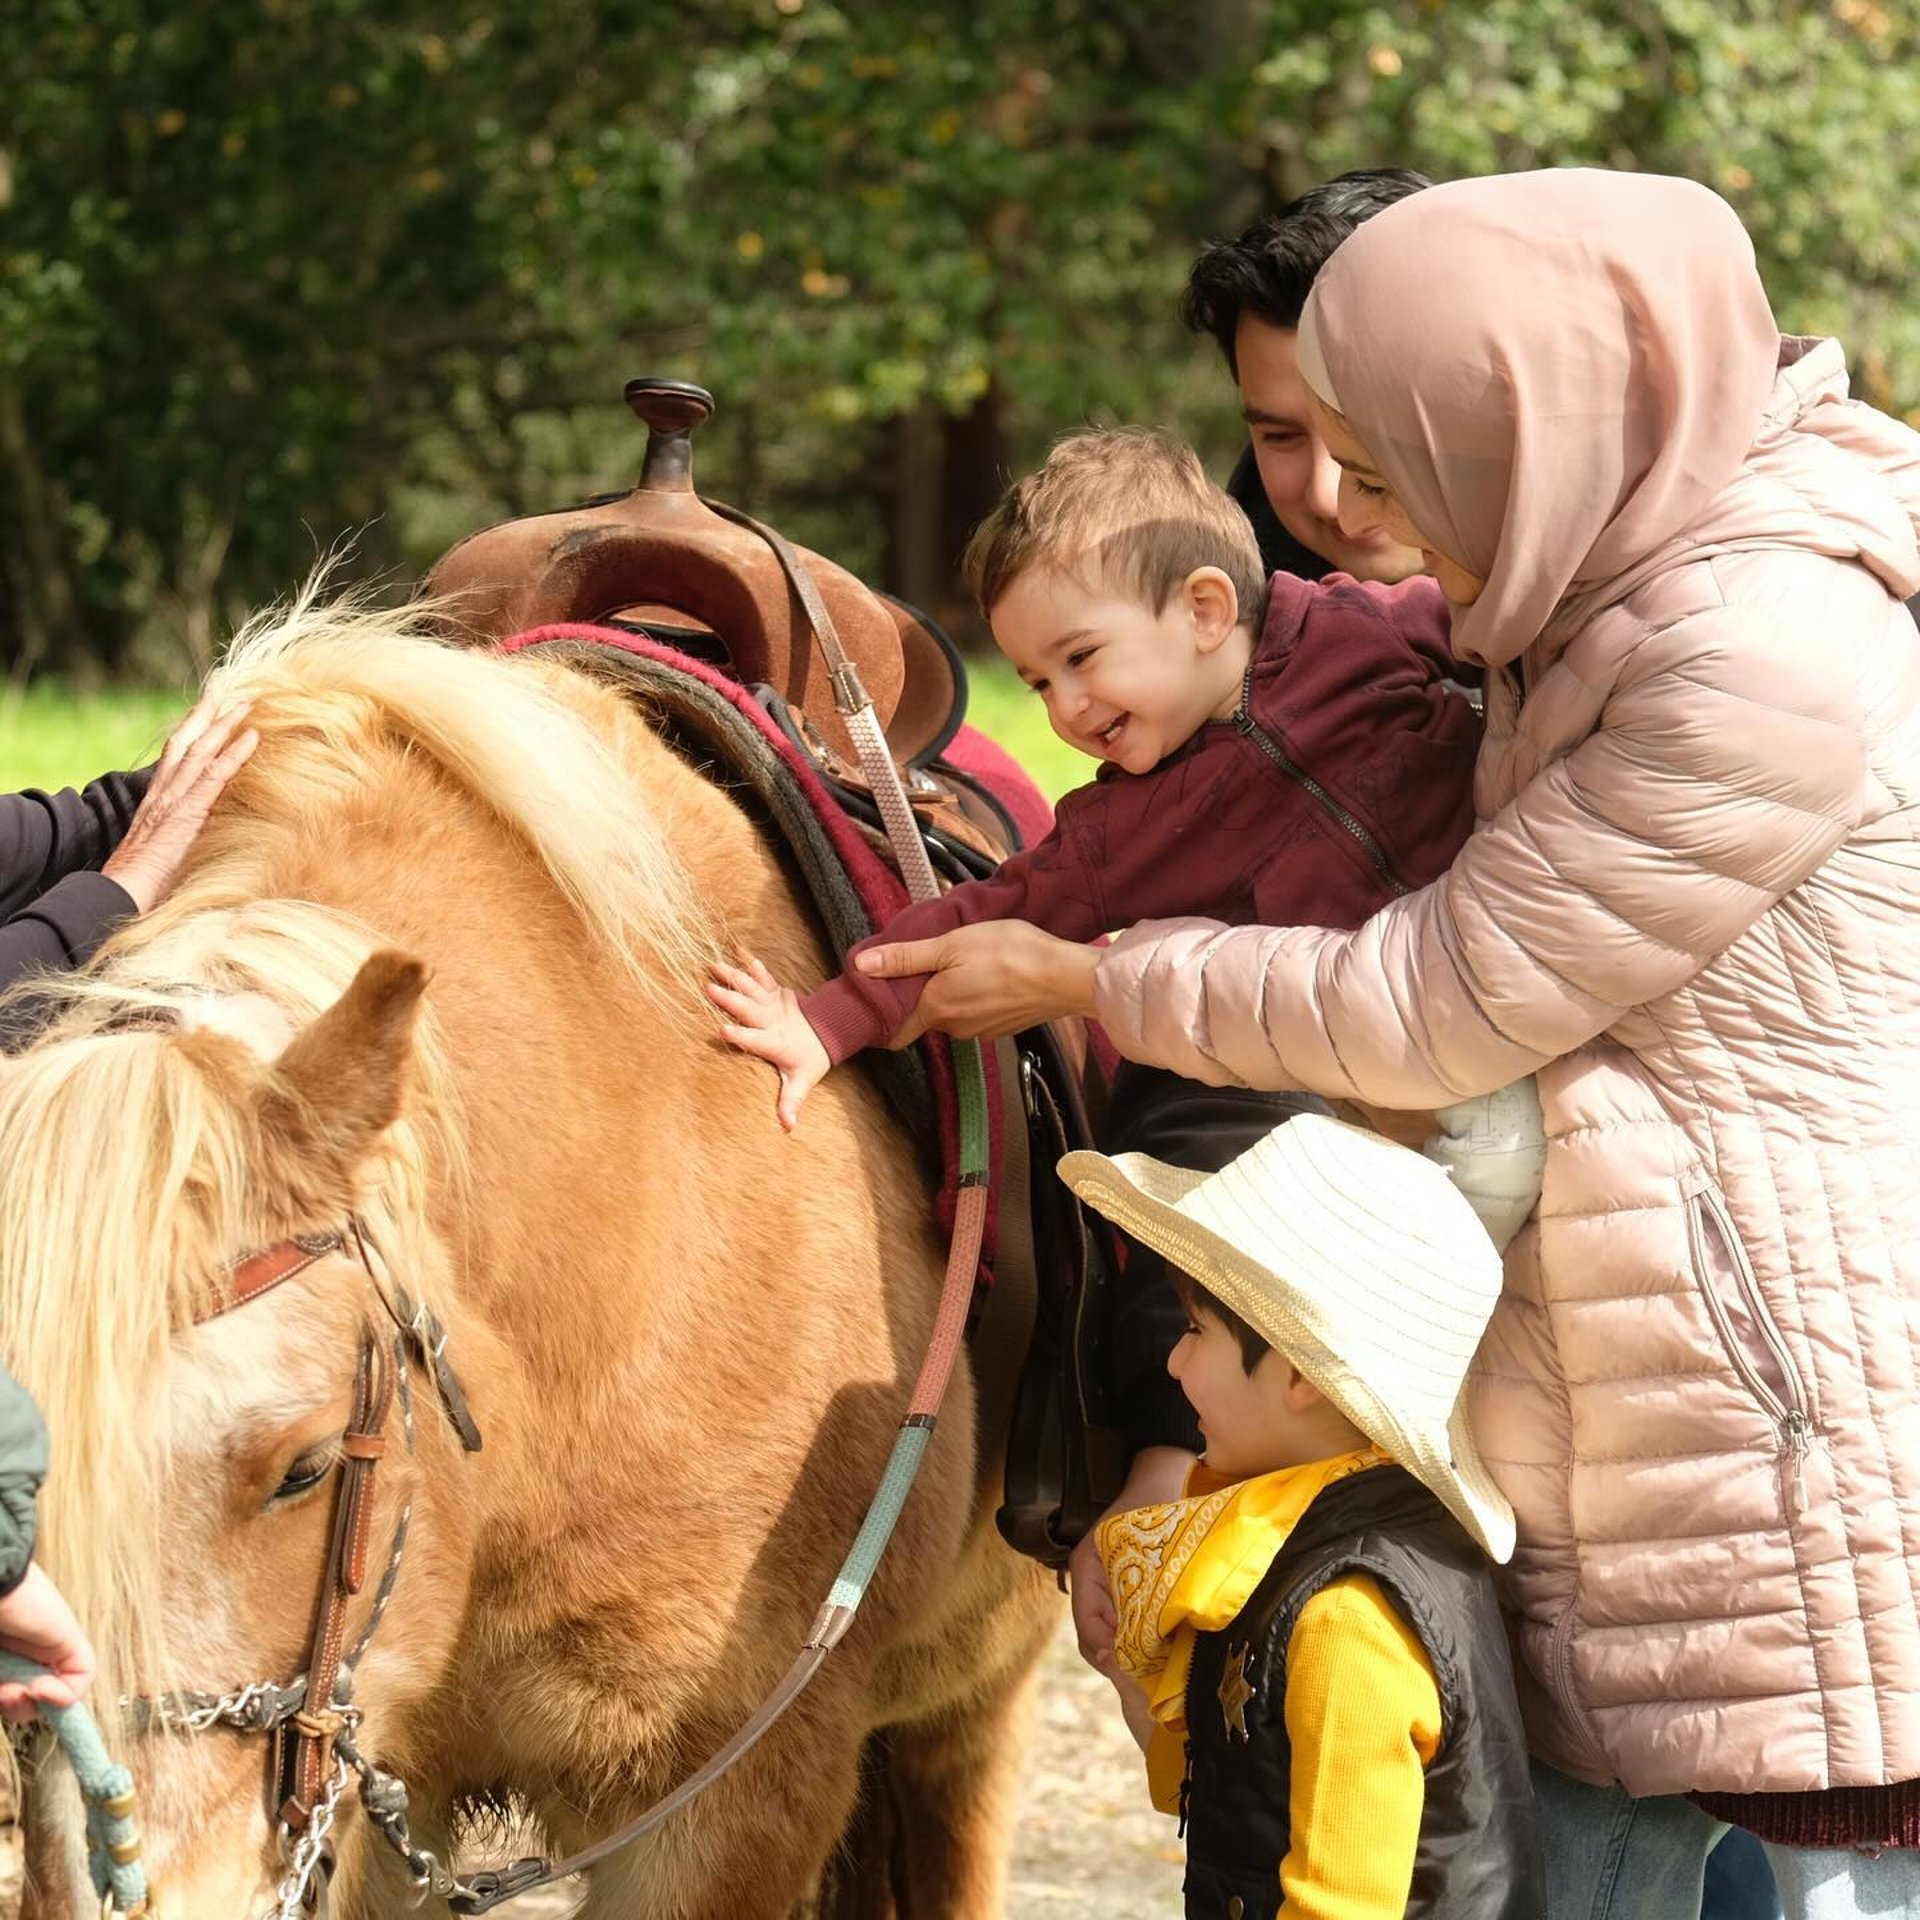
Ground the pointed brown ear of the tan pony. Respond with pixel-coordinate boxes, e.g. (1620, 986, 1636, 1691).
(259, 948, 426, 1212)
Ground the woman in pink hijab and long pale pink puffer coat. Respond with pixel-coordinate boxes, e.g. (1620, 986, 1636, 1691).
(876, 171, 1920, 1920)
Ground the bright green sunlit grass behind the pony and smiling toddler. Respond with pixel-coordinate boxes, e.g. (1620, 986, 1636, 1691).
(0, 655, 1092, 801)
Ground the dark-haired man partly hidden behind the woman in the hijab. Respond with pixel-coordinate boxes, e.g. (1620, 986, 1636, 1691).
(1181, 167, 1432, 584)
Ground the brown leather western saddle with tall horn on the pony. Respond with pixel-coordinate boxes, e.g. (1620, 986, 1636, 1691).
(424, 378, 1125, 1567)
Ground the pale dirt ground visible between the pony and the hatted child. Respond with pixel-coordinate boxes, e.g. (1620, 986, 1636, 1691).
(503, 1626, 1183, 1920)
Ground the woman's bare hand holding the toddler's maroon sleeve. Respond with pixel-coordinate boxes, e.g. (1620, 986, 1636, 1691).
(854, 920, 1100, 1046)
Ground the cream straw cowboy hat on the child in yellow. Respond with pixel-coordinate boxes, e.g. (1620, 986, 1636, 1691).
(1060, 1114, 1513, 1561)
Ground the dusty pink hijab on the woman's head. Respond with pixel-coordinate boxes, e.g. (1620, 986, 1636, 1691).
(1300, 171, 1780, 666)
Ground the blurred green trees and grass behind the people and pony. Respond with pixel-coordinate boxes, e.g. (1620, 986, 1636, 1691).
(0, 0, 1920, 785)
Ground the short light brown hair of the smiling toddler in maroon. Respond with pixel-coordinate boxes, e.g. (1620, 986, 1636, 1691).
(962, 426, 1267, 626)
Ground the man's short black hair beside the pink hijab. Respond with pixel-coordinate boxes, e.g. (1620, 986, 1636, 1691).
(1181, 167, 1432, 378)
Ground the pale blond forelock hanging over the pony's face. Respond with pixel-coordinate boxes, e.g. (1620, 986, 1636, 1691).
(0, 900, 465, 1699)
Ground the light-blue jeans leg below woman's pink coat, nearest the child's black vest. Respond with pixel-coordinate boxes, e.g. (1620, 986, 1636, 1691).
(1534, 1761, 1726, 1920)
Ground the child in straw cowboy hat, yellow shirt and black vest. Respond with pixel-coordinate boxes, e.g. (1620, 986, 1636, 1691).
(1060, 1116, 1544, 1920)
